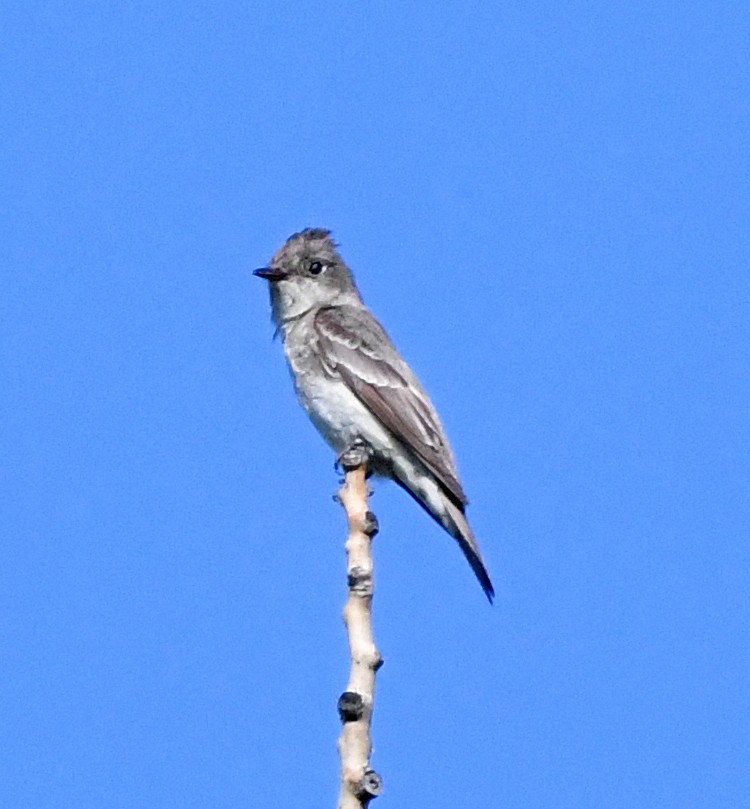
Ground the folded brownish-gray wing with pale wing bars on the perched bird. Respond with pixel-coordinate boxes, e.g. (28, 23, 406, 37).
(314, 306, 468, 510)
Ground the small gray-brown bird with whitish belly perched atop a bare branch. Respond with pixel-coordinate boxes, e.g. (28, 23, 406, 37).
(255, 228, 495, 601)
